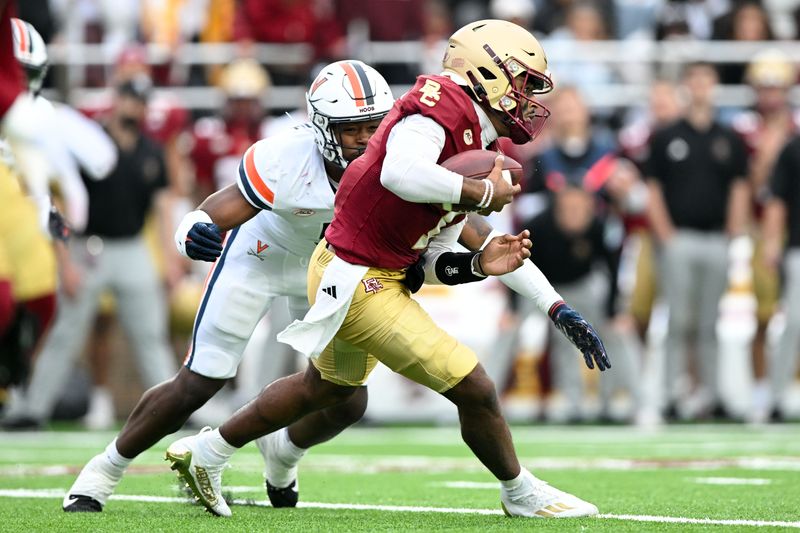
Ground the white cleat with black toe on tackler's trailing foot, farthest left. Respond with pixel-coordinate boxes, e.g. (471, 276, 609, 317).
(62, 453, 124, 513)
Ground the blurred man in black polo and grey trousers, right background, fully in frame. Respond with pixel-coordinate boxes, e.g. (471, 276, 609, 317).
(645, 63, 748, 417)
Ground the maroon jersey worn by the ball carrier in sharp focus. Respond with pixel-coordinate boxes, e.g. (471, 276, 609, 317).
(325, 76, 482, 269)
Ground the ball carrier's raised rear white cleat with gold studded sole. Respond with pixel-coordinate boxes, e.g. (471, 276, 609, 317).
(166, 427, 232, 517)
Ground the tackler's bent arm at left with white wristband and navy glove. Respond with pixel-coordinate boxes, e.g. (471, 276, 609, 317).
(175, 184, 259, 262)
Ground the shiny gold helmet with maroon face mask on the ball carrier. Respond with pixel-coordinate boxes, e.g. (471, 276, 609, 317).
(442, 20, 553, 144)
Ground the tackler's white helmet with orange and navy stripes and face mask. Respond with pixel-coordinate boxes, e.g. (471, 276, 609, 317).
(306, 60, 394, 168)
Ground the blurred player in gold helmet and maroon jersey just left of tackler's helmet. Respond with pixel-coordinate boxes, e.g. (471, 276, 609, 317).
(190, 59, 271, 202)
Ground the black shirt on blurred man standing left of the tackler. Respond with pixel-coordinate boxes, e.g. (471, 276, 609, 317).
(83, 135, 168, 238)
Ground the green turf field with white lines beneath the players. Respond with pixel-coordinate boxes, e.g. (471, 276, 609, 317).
(0, 425, 800, 532)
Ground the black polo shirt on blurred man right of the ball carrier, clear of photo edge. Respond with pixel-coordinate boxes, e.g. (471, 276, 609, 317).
(645, 119, 747, 231)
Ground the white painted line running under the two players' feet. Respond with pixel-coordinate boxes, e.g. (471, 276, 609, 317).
(0, 487, 800, 529)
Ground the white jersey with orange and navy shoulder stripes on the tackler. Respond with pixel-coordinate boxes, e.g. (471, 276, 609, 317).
(236, 124, 335, 257)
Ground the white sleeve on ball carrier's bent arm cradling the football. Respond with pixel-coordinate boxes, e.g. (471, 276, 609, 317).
(381, 115, 464, 204)
